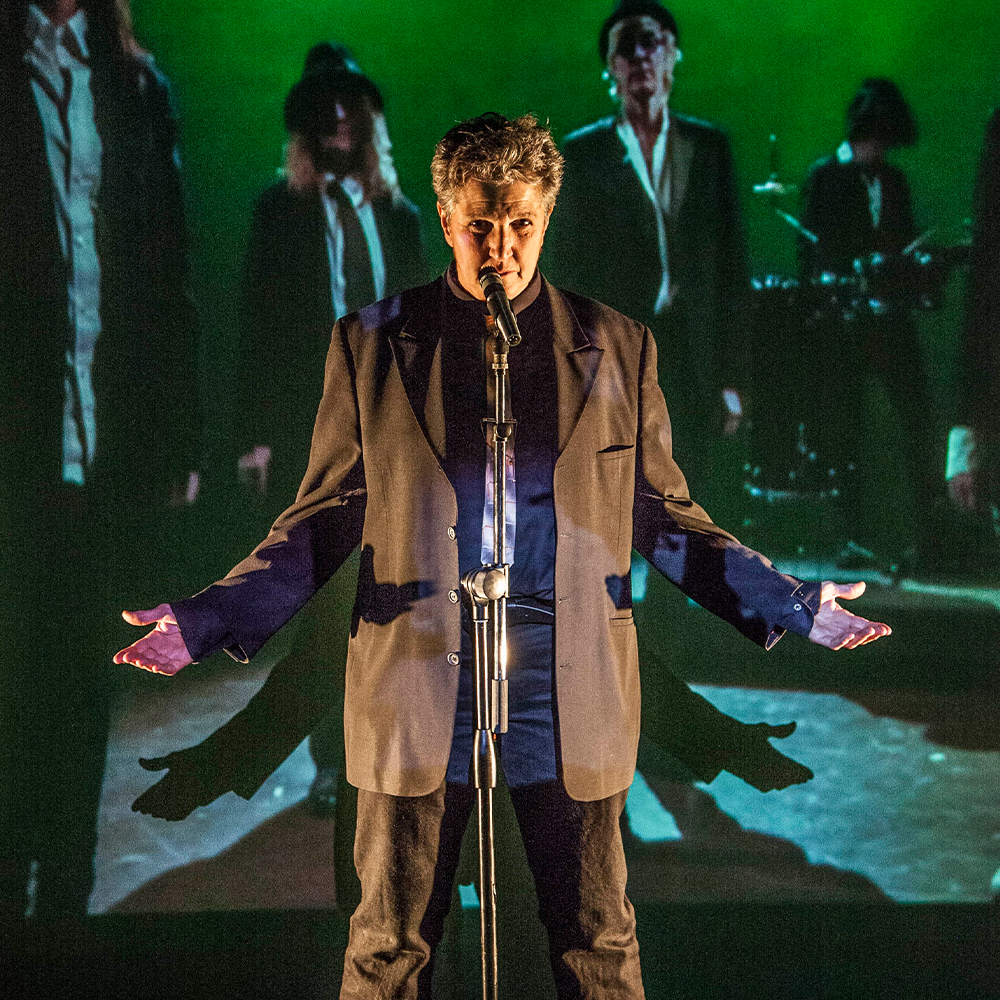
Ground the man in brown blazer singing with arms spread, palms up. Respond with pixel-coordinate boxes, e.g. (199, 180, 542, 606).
(116, 114, 889, 1000)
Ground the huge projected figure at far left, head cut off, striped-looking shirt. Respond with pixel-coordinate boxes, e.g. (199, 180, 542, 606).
(0, 0, 199, 917)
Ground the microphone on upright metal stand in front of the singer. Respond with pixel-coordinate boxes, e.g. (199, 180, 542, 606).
(462, 266, 521, 1000)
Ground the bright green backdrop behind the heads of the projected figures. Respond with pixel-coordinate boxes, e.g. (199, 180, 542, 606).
(133, 0, 1000, 498)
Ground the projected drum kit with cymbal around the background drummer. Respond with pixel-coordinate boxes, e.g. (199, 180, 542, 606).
(744, 135, 969, 556)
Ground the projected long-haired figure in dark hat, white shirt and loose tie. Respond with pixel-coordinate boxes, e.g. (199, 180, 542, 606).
(239, 42, 430, 912)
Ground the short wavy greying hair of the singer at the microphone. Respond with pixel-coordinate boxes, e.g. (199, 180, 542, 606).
(431, 111, 563, 217)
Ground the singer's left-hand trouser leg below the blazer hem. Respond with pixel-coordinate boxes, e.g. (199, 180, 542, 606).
(340, 785, 475, 1000)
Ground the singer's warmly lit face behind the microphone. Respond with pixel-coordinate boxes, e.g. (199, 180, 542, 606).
(438, 181, 552, 299)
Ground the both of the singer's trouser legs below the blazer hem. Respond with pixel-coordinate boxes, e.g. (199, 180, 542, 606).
(340, 782, 644, 1000)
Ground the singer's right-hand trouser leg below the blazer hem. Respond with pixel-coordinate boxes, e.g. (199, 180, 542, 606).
(510, 782, 644, 1000)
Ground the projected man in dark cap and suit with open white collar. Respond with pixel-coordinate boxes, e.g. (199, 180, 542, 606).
(549, 0, 749, 503)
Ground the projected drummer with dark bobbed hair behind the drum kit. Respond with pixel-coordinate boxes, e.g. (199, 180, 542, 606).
(800, 78, 944, 568)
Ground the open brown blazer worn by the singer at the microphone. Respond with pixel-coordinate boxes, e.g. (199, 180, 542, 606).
(175, 279, 799, 800)
